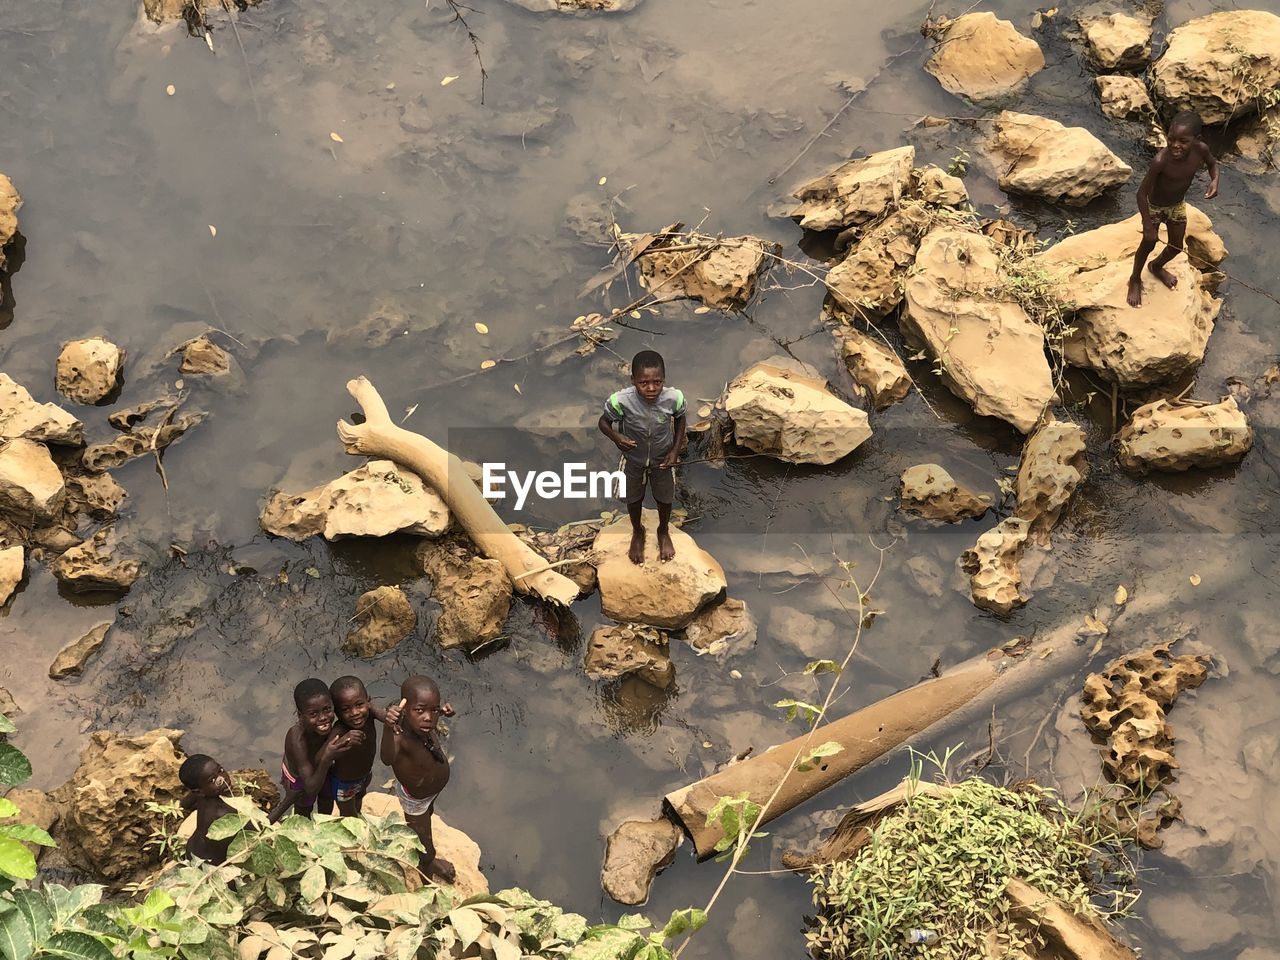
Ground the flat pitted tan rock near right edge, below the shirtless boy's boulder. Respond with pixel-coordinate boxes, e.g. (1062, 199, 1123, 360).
(1116, 397, 1253, 474)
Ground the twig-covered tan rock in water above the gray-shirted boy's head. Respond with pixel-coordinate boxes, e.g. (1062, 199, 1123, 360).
(632, 234, 782, 310)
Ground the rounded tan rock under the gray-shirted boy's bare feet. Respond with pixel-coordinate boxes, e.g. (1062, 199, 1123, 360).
(591, 509, 726, 630)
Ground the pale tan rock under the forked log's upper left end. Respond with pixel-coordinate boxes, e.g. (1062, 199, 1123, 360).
(259, 460, 449, 540)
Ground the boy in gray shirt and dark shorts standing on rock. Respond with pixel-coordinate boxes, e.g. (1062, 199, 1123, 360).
(599, 349, 685, 564)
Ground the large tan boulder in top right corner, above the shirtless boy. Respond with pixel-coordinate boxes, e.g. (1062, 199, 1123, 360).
(1152, 10, 1280, 124)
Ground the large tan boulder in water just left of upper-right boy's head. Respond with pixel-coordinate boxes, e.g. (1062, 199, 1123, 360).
(991, 110, 1133, 206)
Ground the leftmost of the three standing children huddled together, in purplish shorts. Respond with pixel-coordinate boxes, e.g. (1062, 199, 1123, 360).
(269, 677, 365, 823)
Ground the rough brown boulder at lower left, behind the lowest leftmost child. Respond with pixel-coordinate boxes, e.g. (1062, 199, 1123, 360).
(54, 730, 187, 882)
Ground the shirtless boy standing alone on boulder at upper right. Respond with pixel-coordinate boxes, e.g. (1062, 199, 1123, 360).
(1129, 110, 1219, 307)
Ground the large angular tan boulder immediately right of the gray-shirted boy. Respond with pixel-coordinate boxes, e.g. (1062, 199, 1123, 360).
(724, 357, 872, 463)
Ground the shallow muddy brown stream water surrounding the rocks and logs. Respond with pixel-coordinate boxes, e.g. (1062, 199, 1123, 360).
(0, 0, 1280, 960)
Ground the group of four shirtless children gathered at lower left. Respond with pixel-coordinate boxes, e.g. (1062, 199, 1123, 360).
(178, 676, 454, 883)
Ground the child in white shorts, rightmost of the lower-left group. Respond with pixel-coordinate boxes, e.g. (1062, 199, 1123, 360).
(381, 677, 456, 883)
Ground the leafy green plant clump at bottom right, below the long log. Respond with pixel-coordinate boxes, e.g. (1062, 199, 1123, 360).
(805, 780, 1137, 960)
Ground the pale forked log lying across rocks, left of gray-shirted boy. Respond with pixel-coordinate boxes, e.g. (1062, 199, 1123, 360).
(338, 376, 579, 605)
